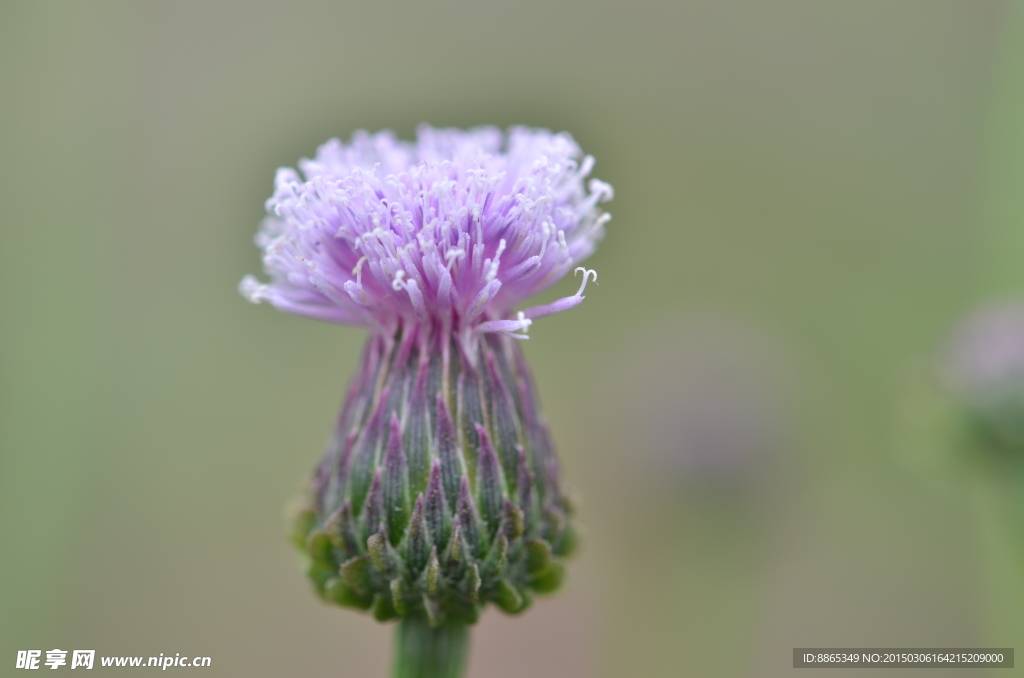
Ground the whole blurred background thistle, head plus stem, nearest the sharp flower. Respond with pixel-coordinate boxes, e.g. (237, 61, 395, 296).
(588, 311, 795, 676)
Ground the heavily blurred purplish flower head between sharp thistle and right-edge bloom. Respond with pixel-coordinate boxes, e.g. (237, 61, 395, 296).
(615, 314, 792, 488)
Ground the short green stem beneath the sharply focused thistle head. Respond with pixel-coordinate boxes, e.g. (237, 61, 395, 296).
(391, 616, 469, 678)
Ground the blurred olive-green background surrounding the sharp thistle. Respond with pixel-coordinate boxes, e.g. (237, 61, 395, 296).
(0, 0, 1024, 678)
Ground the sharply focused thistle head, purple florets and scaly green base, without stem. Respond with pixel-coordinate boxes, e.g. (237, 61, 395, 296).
(250, 127, 611, 625)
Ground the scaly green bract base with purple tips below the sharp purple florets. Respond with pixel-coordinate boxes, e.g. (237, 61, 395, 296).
(293, 323, 577, 625)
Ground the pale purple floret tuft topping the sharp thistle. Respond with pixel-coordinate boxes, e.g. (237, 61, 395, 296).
(240, 126, 612, 337)
